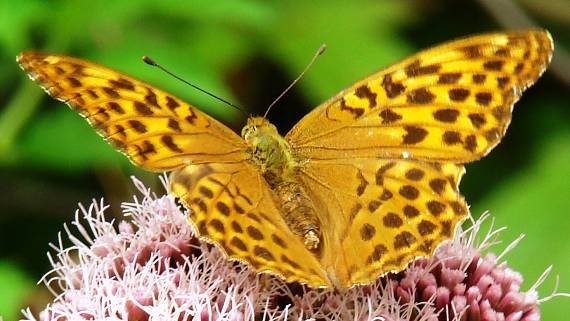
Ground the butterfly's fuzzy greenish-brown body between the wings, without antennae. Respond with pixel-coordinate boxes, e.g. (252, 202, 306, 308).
(242, 117, 321, 250)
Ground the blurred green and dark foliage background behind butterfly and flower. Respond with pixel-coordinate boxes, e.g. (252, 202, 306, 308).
(0, 0, 570, 321)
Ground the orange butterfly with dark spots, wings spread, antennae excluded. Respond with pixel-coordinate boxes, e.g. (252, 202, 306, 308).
(17, 30, 553, 289)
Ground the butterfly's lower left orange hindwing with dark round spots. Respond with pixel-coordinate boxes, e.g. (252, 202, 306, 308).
(170, 163, 331, 287)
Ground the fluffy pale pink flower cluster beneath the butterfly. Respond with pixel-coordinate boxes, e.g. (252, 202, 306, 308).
(23, 180, 556, 321)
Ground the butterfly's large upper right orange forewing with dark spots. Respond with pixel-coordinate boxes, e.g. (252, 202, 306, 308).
(286, 31, 553, 163)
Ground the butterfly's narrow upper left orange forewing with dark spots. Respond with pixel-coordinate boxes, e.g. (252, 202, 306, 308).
(18, 52, 245, 172)
